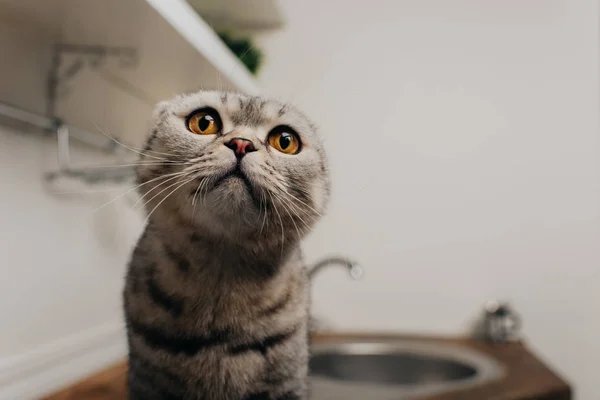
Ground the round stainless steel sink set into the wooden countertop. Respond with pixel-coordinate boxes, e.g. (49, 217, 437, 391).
(310, 340, 502, 400)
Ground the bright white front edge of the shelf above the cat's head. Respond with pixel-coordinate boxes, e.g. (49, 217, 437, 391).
(146, 0, 260, 94)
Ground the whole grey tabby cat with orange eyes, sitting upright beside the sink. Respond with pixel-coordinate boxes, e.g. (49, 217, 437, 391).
(124, 91, 329, 400)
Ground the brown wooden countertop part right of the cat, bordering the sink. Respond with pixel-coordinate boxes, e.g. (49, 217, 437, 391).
(312, 333, 572, 400)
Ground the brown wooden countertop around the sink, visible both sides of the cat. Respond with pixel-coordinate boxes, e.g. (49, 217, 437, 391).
(44, 333, 572, 400)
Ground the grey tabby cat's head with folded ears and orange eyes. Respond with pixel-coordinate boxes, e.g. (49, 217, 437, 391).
(138, 91, 329, 241)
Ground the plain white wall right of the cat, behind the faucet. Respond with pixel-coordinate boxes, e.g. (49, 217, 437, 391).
(262, 0, 600, 400)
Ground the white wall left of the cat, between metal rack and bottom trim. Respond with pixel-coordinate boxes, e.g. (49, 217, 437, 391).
(0, 130, 142, 357)
